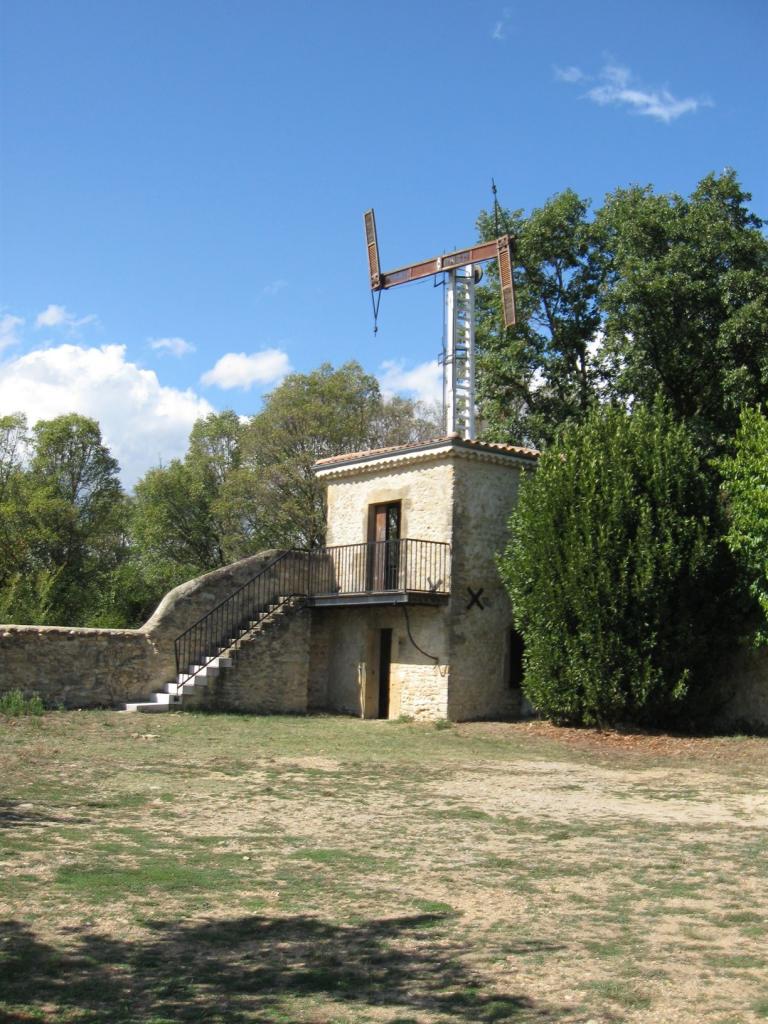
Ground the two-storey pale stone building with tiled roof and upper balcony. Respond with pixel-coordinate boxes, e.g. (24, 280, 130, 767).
(310, 435, 537, 720)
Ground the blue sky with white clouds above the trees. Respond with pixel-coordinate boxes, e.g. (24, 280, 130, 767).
(0, 0, 768, 483)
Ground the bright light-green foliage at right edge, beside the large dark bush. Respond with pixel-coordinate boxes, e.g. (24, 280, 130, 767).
(720, 408, 768, 644)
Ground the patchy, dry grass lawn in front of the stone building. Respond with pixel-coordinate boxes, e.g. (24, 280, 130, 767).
(0, 712, 768, 1024)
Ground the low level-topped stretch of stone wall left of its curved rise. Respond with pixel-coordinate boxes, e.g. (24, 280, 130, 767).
(0, 626, 159, 708)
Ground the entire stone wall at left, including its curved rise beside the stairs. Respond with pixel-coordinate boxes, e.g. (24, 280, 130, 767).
(0, 551, 313, 708)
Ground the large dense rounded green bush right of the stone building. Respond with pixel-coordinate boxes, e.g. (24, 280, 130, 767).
(501, 403, 723, 725)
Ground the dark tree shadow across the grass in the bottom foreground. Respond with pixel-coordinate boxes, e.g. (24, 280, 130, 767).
(0, 913, 565, 1024)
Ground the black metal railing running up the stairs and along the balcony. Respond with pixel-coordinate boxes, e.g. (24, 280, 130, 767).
(175, 539, 451, 685)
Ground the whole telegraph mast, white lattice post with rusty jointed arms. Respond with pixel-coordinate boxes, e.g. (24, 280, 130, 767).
(365, 210, 515, 439)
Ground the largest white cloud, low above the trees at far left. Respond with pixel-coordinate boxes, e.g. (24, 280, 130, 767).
(0, 344, 214, 486)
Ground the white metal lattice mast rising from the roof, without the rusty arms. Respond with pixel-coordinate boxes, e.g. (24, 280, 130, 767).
(442, 263, 475, 440)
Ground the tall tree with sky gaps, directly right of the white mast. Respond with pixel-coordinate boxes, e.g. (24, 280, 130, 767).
(477, 189, 603, 446)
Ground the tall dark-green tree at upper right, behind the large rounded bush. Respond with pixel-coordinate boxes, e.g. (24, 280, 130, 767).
(595, 170, 768, 451)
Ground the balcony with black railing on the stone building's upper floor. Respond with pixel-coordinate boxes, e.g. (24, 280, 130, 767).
(307, 539, 451, 607)
